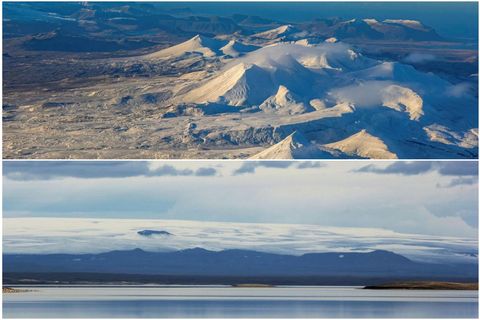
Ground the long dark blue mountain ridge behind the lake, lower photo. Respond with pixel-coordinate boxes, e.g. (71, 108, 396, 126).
(3, 248, 477, 278)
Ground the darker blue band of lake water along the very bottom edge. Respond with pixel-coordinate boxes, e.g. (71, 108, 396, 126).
(3, 300, 478, 318)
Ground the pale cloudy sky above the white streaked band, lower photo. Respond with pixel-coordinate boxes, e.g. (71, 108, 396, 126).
(3, 161, 478, 238)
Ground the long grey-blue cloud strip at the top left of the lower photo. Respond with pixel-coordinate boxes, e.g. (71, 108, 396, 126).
(3, 161, 217, 181)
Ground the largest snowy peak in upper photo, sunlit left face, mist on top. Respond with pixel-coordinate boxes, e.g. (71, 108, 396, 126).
(183, 44, 369, 106)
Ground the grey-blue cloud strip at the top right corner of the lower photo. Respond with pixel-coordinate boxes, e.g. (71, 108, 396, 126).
(354, 161, 478, 176)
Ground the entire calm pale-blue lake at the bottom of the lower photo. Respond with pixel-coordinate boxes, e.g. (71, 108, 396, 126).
(3, 286, 478, 318)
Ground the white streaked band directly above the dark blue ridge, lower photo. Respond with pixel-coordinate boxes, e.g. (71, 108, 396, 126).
(3, 218, 477, 262)
